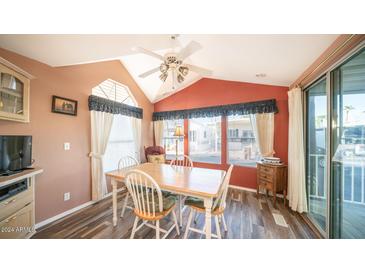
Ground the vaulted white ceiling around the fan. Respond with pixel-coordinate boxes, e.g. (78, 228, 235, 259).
(0, 34, 338, 102)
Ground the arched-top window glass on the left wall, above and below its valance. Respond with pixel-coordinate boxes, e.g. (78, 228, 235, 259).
(92, 79, 138, 172)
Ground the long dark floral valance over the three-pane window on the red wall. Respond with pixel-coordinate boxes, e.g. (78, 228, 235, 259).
(153, 99, 278, 121)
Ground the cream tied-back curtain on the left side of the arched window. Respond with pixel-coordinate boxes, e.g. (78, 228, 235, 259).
(89, 111, 114, 201)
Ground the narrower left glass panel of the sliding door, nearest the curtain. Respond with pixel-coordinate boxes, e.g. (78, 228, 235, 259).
(305, 79, 327, 233)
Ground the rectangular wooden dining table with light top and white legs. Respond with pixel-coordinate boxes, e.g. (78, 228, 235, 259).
(106, 163, 226, 239)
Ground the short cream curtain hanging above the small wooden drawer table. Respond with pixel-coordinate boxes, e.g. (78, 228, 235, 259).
(251, 113, 275, 157)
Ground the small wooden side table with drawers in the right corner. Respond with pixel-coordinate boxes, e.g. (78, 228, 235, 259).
(257, 162, 288, 207)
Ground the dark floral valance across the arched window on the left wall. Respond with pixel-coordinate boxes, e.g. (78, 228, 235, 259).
(89, 95, 143, 119)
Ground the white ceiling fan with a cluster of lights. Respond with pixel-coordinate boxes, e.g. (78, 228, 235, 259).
(133, 35, 212, 90)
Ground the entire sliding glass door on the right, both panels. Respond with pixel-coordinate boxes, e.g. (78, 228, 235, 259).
(305, 47, 365, 239)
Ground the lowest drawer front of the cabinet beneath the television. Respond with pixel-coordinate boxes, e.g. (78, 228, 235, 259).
(0, 203, 34, 239)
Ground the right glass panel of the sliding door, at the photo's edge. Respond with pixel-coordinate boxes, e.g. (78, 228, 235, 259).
(331, 50, 365, 238)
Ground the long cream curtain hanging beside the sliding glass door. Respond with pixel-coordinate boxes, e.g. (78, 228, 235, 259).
(288, 88, 307, 213)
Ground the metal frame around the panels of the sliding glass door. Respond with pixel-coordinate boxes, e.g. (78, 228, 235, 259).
(302, 41, 365, 238)
